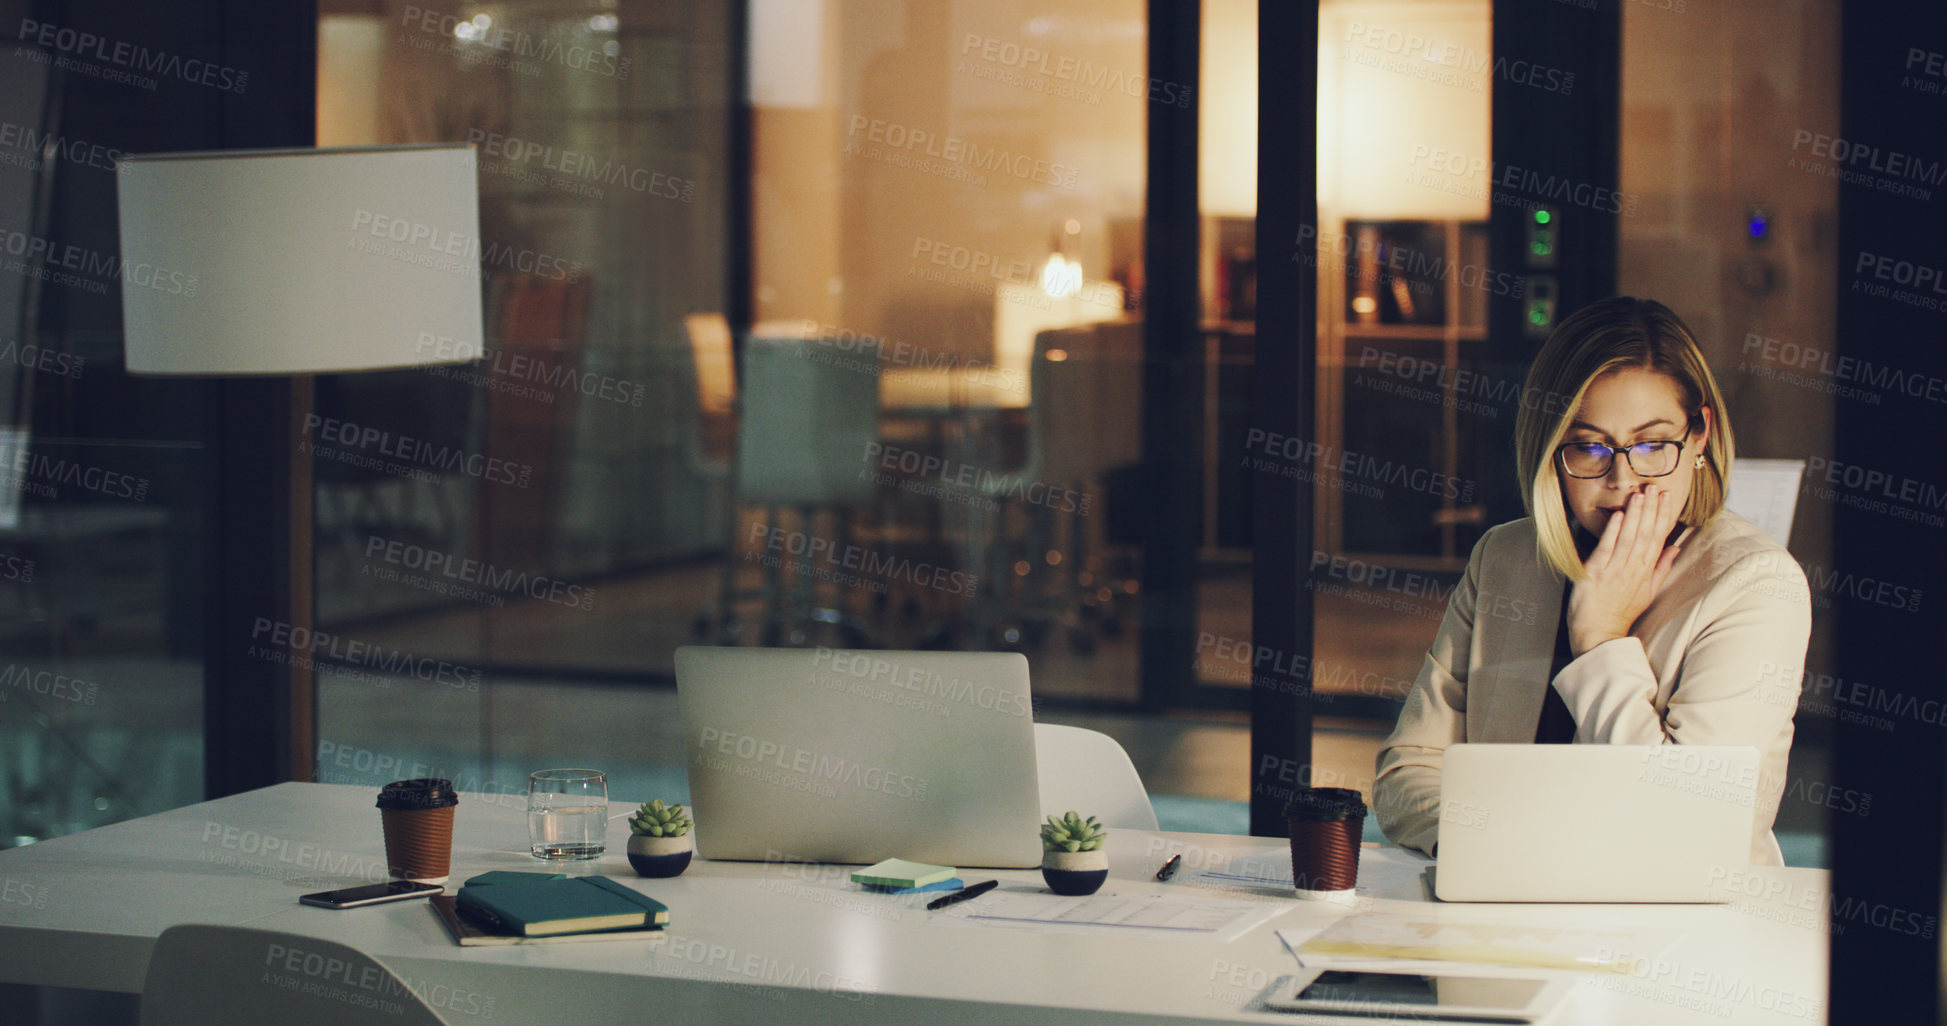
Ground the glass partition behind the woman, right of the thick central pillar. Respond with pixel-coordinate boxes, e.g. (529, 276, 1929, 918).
(1292, 0, 1837, 866)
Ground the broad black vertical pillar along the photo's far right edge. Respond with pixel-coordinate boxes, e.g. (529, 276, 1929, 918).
(1803, 4, 1947, 1022)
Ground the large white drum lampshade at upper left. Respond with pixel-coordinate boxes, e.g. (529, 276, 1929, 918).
(117, 144, 483, 374)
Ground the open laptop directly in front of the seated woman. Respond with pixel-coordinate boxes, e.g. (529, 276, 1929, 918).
(1429, 744, 1758, 901)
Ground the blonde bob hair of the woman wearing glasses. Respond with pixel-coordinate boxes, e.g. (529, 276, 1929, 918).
(1515, 296, 1735, 580)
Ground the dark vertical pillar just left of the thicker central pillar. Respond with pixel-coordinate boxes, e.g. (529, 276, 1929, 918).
(1141, 0, 1203, 709)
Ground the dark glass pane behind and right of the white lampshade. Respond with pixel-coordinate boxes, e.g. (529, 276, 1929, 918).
(310, 0, 742, 796)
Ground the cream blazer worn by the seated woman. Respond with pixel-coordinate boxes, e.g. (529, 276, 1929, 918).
(1373, 510, 1811, 866)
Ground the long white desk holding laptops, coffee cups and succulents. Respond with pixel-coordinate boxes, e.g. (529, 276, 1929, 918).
(0, 785, 1822, 1026)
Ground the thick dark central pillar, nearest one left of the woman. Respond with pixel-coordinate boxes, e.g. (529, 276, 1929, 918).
(1250, 0, 1318, 835)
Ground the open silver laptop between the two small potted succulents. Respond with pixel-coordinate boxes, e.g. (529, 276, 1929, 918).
(676, 646, 1042, 868)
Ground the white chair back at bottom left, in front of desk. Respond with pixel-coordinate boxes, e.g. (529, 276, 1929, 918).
(142, 925, 446, 1026)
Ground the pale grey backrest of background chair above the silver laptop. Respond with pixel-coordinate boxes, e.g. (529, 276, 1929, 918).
(736, 335, 878, 504)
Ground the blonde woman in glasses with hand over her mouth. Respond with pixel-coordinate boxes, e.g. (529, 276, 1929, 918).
(1373, 298, 1811, 866)
